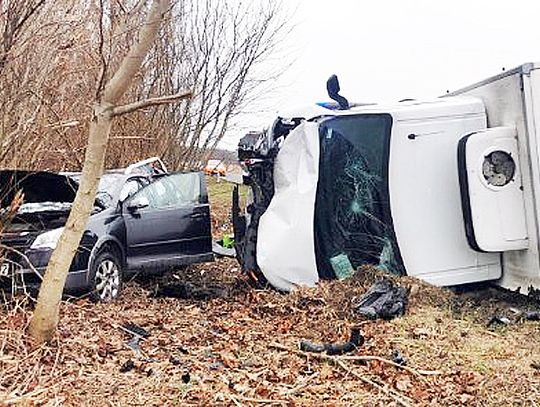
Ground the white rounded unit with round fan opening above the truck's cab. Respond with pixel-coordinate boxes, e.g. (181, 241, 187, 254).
(462, 127, 529, 252)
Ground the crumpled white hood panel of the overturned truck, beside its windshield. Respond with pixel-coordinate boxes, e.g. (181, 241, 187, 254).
(257, 122, 319, 291)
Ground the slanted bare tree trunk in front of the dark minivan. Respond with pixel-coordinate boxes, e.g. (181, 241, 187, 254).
(29, 0, 169, 343)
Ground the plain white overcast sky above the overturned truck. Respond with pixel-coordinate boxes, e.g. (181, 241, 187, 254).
(218, 0, 540, 149)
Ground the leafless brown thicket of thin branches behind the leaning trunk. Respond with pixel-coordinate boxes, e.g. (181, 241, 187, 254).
(0, 0, 289, 170)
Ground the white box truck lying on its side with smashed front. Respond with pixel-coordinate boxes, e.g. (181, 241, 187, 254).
(233, 63, 540, 296)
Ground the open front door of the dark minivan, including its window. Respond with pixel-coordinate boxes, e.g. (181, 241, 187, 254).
(123, 173, 212, 269)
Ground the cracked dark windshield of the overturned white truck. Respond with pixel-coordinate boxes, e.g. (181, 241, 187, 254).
(314, 114, 403, 278)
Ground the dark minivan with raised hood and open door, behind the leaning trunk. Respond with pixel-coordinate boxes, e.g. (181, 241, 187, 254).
(0, 160, 213, 301)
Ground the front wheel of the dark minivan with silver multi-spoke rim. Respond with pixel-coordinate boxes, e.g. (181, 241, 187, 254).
(90, 251, 122, 302)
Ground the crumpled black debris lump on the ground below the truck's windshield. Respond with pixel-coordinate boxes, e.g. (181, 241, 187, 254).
(355, 279, 408, 320)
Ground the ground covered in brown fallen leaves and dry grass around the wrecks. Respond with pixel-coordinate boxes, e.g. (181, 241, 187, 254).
(0, 177, 540, 406)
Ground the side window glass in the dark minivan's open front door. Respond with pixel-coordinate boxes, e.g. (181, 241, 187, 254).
(137, 173, 201, 209)
